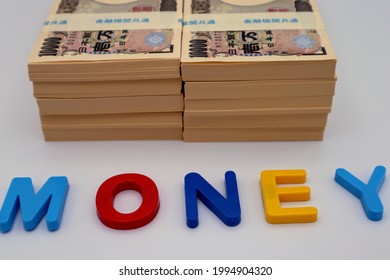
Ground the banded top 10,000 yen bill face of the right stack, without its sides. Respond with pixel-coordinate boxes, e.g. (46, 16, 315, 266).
(182, 0, 333, 63)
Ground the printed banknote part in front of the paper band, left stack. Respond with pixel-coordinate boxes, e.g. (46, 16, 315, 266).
(38, 29, 174, 57)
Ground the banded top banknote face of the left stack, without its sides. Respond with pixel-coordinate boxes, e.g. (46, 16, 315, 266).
(29, 0, 183, 64)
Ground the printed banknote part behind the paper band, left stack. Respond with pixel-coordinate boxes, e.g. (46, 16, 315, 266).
(57, 0, 177, 14)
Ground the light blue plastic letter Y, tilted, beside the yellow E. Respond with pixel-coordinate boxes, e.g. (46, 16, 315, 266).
(335, 166, 386, 221)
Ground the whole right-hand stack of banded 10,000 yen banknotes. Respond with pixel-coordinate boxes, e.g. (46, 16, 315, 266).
(182, 0, 336, 141)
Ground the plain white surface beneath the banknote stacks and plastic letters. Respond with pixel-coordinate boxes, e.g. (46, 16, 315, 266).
(0, 0, 390, 259)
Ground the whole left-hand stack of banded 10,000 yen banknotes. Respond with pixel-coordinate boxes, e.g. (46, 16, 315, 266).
(28, 0, 183, 141)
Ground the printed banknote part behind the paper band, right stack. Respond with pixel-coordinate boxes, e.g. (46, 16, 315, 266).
(191, 0, 313, 14)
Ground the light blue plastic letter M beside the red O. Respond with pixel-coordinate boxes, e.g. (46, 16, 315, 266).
(0, 177, 69, 233)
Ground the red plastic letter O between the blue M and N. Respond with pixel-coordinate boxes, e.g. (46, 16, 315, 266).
(96, 174, 160, 230)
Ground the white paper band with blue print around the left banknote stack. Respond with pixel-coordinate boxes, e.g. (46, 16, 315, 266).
(42, 12, 182, 31)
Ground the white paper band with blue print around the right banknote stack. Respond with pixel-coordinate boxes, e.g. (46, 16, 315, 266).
(183, 12, 325, 31)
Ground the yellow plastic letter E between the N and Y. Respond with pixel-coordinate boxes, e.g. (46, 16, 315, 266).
(260, 170, 318, 224)
